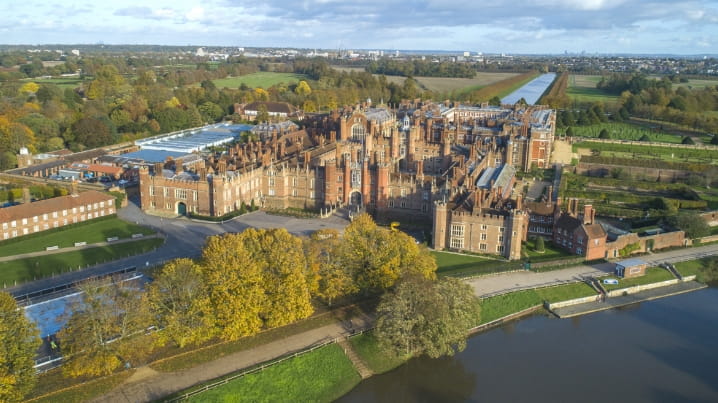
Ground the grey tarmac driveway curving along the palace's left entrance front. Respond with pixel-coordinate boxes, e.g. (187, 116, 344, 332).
(4, 201, 349, 297)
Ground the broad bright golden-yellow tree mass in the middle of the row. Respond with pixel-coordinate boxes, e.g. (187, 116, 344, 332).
(202, 229, 313, 340)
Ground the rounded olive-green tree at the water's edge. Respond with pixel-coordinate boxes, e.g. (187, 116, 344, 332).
(376, 276, 480, 358)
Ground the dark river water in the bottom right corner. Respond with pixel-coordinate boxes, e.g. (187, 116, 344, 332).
(339, 288, 718, 403)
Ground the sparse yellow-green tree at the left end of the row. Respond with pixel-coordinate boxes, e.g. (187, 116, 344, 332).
(58, 278, 152, 377)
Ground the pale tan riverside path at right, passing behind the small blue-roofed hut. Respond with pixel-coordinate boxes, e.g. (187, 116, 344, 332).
(467, 244, 718, 297)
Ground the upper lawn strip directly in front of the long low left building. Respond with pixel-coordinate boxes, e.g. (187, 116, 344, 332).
(0, 217, 154, 256)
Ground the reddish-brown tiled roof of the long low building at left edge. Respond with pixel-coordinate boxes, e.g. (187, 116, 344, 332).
(0, 190, 114, 222)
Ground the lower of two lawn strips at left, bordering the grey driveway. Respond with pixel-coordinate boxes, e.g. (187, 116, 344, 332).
(0, 238, 164, 286)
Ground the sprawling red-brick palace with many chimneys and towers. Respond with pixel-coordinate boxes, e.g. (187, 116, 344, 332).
(139, 100, 555, 259)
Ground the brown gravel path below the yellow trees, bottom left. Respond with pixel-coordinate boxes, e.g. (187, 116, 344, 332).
(92, 317, 370, 403)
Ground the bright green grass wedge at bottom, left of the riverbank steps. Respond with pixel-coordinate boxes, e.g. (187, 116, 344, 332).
(189, 344, 361, 402)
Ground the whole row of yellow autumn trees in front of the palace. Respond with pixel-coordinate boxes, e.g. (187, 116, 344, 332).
(58, 215, 436, 377)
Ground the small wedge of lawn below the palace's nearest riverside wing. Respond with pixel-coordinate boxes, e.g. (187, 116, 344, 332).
(431, 251, 520, 277)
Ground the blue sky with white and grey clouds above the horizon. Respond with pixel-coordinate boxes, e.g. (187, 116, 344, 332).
(0, 0, 718, 54)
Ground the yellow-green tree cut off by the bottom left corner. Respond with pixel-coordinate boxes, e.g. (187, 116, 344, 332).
(0, 292, 40, 402)
